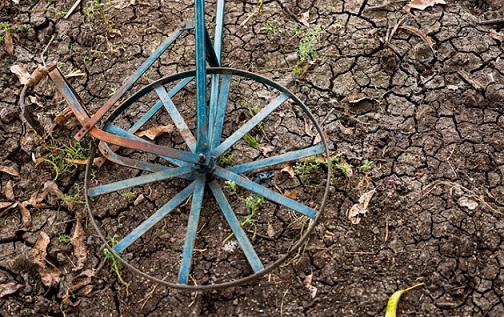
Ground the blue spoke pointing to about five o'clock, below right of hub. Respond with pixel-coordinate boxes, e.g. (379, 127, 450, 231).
(208, 180, 264, 273)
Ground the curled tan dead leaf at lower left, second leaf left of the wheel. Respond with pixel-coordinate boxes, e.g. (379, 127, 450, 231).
(32, 231, 61, 287)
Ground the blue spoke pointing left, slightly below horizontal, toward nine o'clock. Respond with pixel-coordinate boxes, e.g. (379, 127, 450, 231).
(88, 165, 192, 197)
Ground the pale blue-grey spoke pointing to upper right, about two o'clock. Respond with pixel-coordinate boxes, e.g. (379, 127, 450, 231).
(212, 92, 289, 157)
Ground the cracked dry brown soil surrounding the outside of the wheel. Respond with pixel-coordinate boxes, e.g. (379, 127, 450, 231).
(0, 0, 504, 316)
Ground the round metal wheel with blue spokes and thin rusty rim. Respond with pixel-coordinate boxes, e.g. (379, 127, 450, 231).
(85, 68, 330, 290)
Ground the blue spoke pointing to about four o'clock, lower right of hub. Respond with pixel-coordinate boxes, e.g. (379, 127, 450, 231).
(214, 167, 318, 219)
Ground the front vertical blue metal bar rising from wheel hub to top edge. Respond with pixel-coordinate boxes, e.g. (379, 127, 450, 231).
(194, 0, 209, 159)
